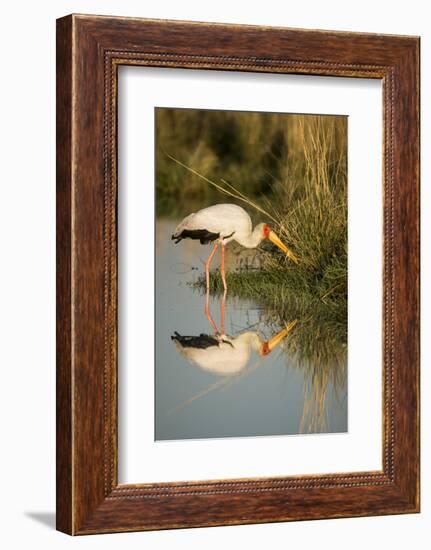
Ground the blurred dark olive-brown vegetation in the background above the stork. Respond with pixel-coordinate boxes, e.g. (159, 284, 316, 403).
(155, 108, 346, 215)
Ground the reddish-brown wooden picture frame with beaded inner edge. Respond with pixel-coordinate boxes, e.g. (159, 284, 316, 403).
(57, 15, 419, 534)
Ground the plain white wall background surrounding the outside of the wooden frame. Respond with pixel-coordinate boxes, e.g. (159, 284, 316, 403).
(0, 0, 431, 550)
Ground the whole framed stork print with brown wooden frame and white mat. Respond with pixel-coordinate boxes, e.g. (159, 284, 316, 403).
(57, 15, 419, 534)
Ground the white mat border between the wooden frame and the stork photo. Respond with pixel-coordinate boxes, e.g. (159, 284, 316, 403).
(117, 70, 383, 484)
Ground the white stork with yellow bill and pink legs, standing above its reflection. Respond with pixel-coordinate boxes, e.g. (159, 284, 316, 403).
(172, 204, 297, 290)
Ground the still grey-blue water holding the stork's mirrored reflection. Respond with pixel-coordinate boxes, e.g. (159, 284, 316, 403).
(155, 219, 347, 440)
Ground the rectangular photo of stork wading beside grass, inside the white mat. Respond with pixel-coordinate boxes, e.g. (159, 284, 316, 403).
(154, 107, 348, 441)
